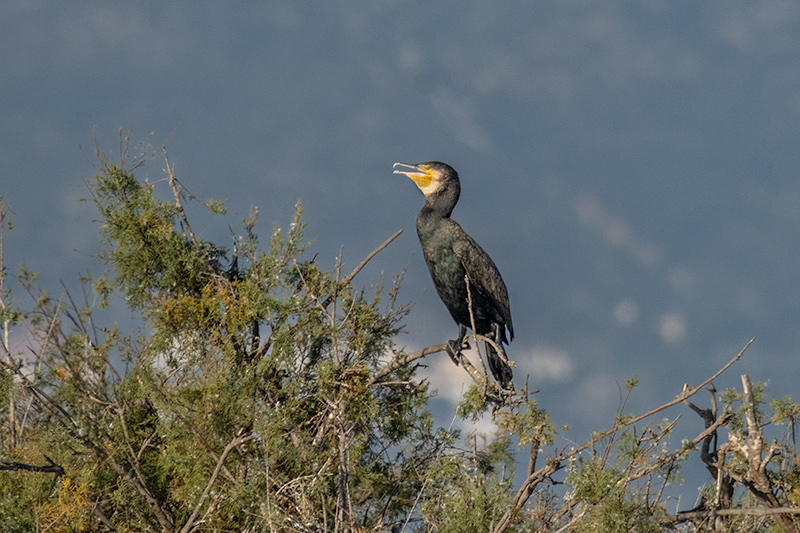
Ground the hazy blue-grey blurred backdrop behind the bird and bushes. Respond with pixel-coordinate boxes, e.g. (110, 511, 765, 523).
(0, 0, 800, 504)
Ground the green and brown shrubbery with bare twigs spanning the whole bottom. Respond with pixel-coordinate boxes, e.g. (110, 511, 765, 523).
(0, 130, 800, 533)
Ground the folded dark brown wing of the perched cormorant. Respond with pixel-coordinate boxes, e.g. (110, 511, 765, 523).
(453, 227, 514, 340)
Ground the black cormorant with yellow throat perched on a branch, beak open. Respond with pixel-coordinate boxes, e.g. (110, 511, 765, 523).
(394, 161, 514, 389)
